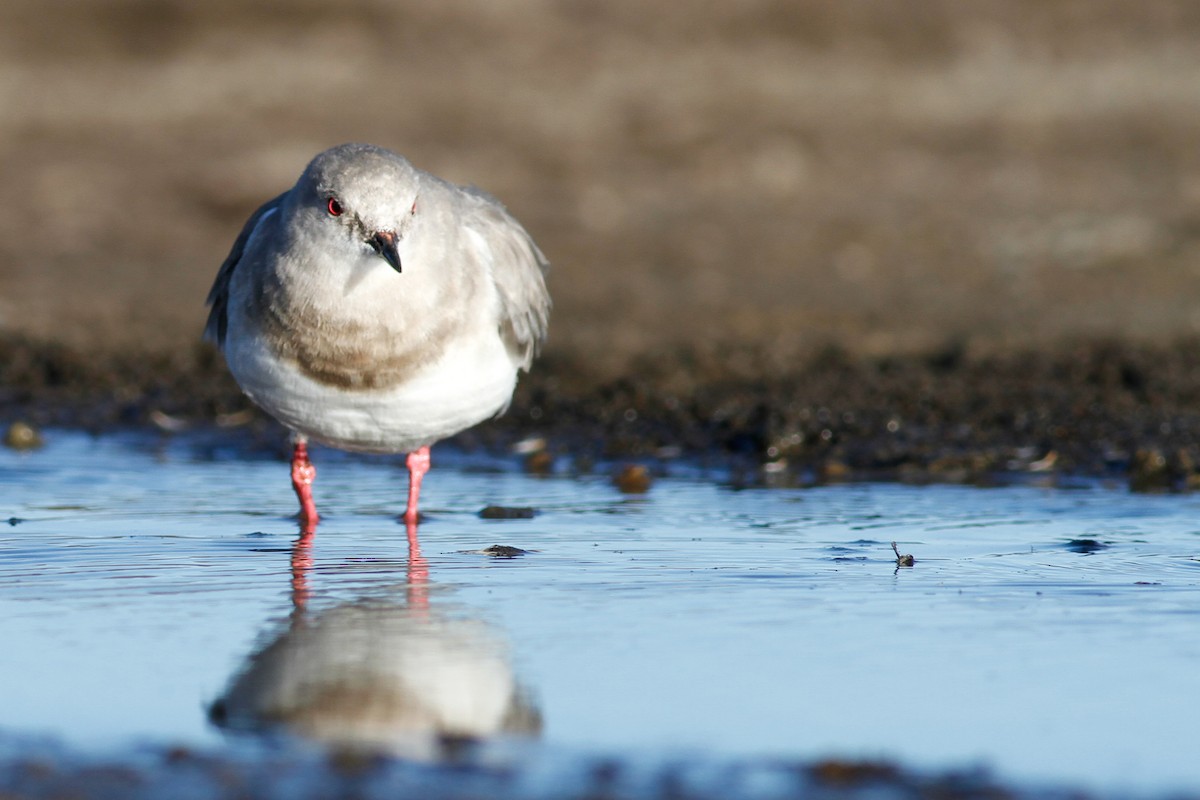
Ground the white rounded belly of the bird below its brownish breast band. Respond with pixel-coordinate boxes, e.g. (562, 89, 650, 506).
(226, 323, 517, 453)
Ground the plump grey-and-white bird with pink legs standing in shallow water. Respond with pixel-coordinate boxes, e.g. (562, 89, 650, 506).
(204, 143, 551, 533)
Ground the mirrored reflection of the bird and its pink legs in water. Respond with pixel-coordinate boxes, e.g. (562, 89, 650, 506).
(209, 528, 541, 759)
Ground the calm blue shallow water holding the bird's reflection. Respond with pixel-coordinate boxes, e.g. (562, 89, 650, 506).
(0, 431, 1200, 792)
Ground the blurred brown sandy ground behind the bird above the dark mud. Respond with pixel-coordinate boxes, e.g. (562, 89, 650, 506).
(0, 0, 1200, 376)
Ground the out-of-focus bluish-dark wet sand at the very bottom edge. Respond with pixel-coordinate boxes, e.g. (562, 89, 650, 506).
(0, 748, 1090, 800)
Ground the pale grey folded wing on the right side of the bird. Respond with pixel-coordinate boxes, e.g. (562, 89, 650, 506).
(463, 187, 551, 369)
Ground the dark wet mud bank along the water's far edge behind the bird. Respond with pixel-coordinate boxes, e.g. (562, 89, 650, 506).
(7, 337, 1200, 491)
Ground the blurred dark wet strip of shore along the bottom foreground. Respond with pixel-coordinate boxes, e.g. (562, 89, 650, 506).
(0, 734, 1108, 800)
